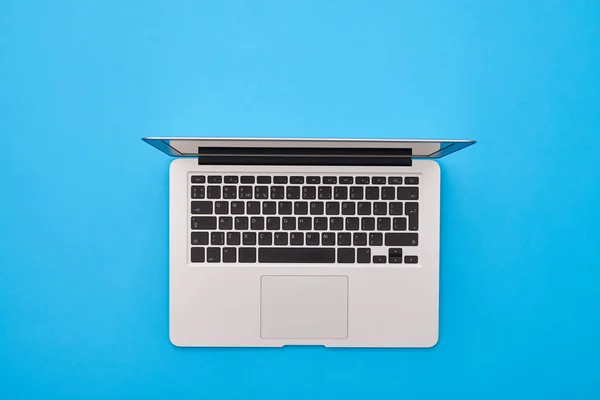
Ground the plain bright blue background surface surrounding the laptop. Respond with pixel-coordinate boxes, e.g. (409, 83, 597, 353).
(0, 0, 600, 399)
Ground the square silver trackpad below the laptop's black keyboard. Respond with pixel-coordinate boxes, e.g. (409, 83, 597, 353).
(260, 276, 348, 339)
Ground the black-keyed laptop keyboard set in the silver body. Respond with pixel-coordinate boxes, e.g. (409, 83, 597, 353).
(189, 174, 419, 264)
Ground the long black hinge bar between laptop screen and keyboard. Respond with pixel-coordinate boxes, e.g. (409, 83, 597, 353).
(198, 147, 412, 167)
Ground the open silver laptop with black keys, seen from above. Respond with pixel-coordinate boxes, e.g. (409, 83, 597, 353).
(143, 137, 474, 347)
